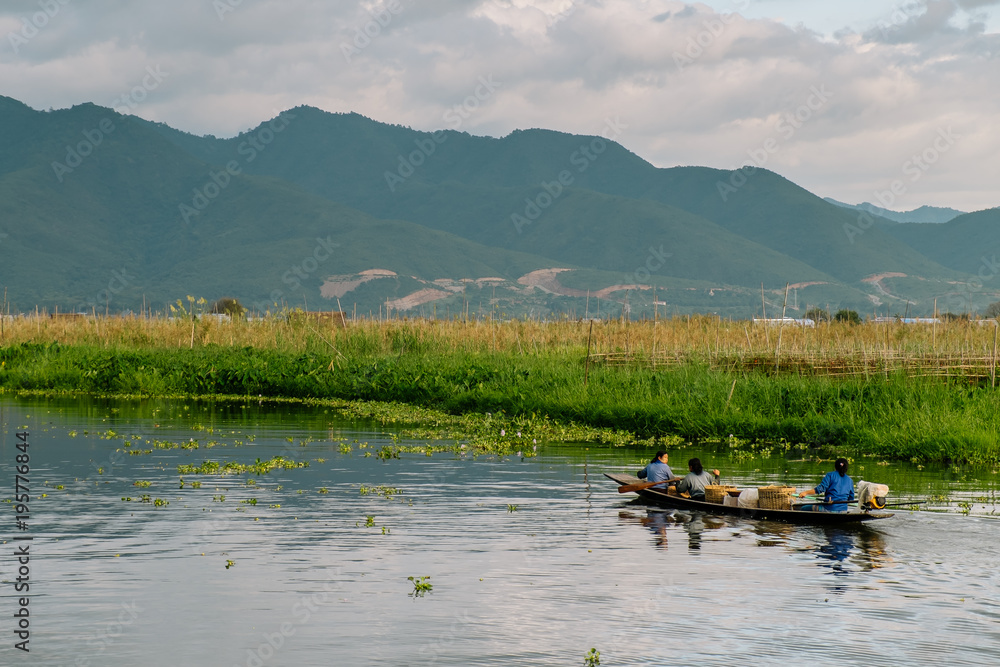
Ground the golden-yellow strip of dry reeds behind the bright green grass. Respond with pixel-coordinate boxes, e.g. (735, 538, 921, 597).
(0, 314, 997, 361)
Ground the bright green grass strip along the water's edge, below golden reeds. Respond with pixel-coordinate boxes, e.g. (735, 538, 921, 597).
(0, 340, 1000, 463)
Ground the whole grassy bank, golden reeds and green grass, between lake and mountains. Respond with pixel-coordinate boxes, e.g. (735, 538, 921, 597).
(0, 318, 1000, 462)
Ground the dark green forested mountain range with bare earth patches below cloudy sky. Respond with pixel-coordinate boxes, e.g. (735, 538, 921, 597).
(0, 97, 1000, 317)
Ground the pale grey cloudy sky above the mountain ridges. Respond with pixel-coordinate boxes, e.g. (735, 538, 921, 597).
(0, 0, 1000, 210)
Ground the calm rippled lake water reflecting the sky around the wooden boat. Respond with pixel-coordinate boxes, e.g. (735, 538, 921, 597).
(0, 396, 1000, 667)
